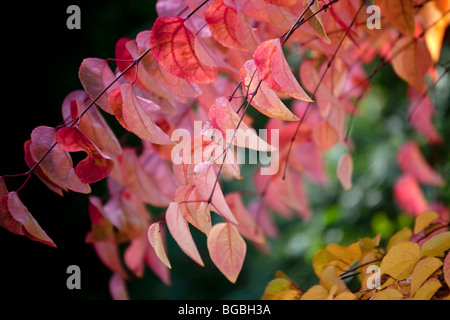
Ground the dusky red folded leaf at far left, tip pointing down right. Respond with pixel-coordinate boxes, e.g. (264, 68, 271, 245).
(7, 191, 56, 247)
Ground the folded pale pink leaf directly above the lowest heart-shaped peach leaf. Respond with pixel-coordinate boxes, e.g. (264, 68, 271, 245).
(194, 162, 238, 224)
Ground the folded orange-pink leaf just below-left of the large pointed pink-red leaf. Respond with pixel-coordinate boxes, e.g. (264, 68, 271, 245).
(240, 60, 299, 121)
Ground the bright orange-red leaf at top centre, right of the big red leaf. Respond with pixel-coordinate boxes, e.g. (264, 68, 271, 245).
(204, 0, 258, 51)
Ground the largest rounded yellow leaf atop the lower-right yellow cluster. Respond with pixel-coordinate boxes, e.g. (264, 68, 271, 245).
(380, 242, 420, 280)
